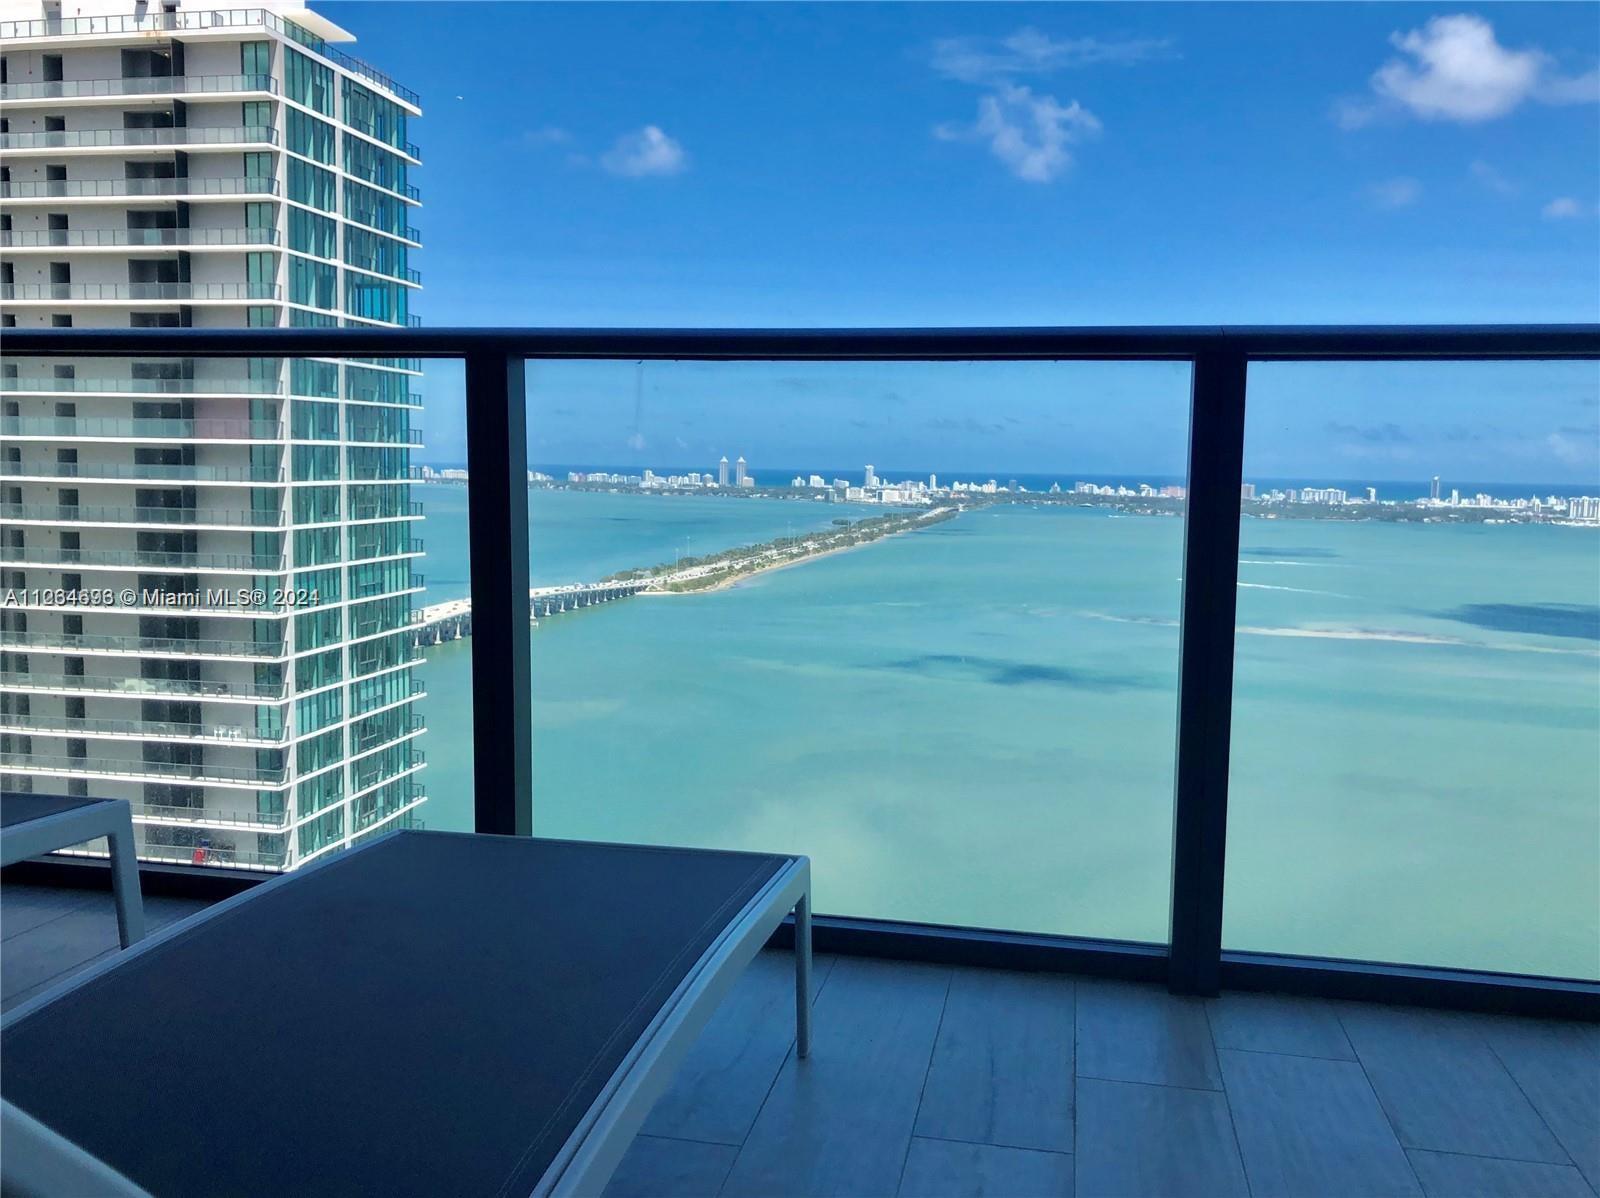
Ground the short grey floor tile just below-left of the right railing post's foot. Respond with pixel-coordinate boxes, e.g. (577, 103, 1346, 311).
(1077, 980, 1222, 1089)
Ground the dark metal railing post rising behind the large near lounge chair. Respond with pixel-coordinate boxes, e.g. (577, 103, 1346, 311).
(466, 342, 533, 837)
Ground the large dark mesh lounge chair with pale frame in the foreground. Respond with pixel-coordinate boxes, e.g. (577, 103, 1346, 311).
(0, 832, 811, 1195)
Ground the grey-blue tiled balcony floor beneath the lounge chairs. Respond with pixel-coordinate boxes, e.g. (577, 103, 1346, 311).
(0, 886, 1600, 1198)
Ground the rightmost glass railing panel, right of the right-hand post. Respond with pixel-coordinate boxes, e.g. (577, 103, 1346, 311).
(1224, 363, 1600, 979)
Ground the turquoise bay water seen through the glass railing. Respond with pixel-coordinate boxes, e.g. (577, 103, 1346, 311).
(419, 488, 1600, 977)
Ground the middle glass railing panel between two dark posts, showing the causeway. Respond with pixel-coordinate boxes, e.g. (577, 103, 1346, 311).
(528, 361, 1189, 942)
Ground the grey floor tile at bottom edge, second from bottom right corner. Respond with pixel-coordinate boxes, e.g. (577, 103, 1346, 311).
(1216, 1049, 1421, 1198)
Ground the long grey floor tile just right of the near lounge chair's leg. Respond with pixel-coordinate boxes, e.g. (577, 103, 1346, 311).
(723, 958, 950, 1198)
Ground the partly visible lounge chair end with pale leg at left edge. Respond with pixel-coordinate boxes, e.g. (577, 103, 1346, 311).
(0, 792, 144, 948)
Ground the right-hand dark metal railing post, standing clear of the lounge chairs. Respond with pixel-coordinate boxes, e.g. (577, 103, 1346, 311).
(1168, 347, 1248, 995)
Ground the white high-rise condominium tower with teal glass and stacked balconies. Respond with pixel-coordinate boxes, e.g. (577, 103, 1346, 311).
(0, 0, 424, 869)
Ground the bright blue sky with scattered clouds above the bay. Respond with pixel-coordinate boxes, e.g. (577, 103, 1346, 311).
(320, 3, 1600, 480)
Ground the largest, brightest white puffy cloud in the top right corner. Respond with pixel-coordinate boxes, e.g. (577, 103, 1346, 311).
(1334, 13, 1600, 128)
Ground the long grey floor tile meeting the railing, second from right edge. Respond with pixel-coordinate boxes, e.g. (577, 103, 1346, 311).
(1339, 1003, 1571, 1164)
